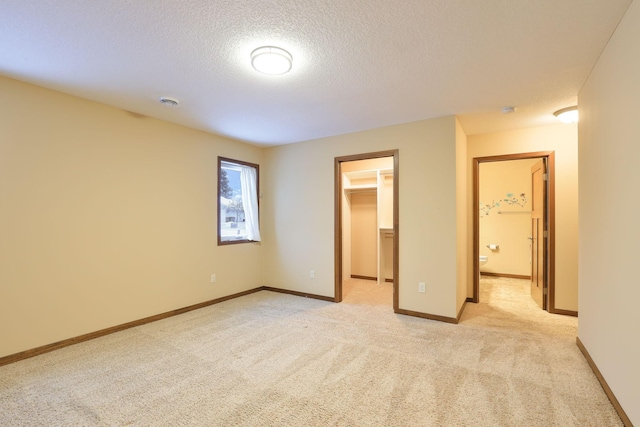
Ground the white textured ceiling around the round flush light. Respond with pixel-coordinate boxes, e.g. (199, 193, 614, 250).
(0, 0, 631, 145)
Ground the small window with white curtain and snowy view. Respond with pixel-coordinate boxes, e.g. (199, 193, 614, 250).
(218, 157, 260, 245)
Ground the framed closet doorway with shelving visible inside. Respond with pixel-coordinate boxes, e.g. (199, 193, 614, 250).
(334, 150, 399, 311)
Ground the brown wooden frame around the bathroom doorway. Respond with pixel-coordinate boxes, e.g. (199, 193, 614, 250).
(470, 151, 565, 314)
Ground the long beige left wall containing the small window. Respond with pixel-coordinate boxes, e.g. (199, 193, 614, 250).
(0, 77, 262, 357)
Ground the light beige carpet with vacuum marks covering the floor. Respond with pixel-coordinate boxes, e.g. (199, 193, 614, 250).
(0, 279, 622, 426)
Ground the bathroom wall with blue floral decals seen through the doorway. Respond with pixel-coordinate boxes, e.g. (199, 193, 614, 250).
(479, 159, 540, 276)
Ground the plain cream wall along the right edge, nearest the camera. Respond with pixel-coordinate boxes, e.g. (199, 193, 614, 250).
(578, 1, 640, 425)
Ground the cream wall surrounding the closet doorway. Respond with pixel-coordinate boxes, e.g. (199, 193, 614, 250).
(263, 116, 466, 317)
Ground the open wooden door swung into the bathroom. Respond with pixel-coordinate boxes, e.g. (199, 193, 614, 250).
(530, 159, 547, 310)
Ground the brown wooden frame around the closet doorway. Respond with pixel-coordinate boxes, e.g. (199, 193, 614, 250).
(334, 149, 400, 313)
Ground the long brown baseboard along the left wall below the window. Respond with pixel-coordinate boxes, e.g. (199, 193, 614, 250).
(0, 286, 264, 366)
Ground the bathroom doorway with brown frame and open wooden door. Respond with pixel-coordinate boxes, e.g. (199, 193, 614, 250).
(472, 151, 556, 313)
